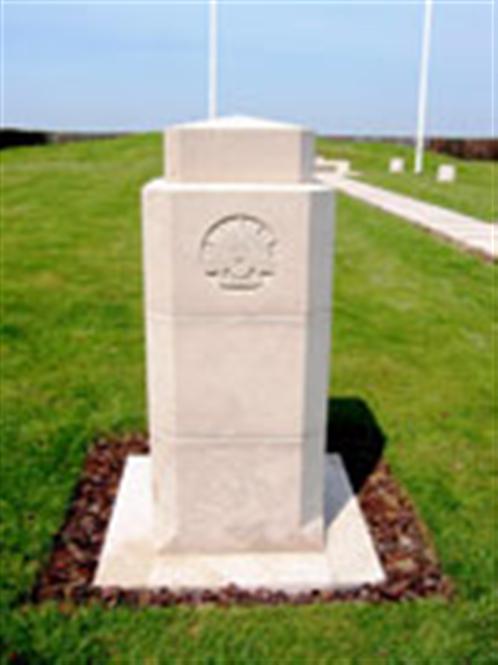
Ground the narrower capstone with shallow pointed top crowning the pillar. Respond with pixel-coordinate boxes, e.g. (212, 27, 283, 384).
(165, 116, 314, 183)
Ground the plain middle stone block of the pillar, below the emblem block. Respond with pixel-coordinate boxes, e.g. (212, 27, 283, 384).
(147, 313, 330, 439)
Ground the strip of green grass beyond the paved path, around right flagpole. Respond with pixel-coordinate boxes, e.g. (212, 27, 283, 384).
(318, 139, 498, 221)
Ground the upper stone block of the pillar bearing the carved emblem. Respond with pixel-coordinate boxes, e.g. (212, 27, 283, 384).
(143, 179, 334, 316)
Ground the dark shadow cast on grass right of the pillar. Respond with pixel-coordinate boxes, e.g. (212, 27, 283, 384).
(326, 397, 387, 493)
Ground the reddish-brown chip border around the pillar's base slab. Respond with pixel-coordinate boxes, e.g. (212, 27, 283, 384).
(33, 434, 452, 606)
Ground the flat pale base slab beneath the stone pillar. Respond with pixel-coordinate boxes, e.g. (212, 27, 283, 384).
(94, 455, 384, 593)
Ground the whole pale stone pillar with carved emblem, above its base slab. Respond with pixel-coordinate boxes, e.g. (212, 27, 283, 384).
(143, 118, 334, 553)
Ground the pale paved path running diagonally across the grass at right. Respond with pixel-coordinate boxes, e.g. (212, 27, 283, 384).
(317, 168, 498, 261)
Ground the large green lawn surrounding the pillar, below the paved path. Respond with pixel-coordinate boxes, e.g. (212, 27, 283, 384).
(0, 135, 498, 665)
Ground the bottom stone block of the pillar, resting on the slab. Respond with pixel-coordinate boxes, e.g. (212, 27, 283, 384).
(153, 436, 324, 554)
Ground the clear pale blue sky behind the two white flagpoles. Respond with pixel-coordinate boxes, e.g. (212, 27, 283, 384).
(2, 0, 497, 135)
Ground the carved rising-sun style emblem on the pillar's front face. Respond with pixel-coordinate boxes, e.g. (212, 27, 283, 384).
(201, 214, 276, 290)
